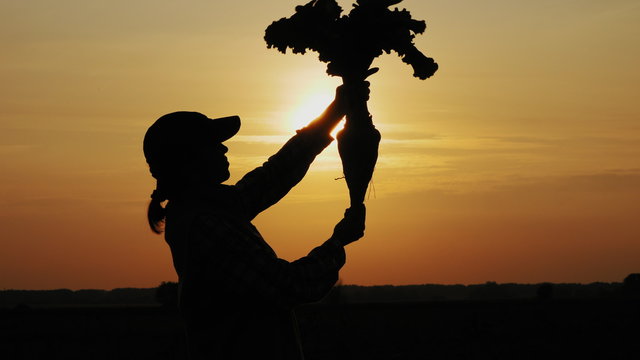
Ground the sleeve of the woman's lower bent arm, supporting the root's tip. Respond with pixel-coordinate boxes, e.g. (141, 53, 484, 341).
(189, 216, 345, 308)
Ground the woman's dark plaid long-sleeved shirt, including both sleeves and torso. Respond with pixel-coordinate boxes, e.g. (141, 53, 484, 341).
(165, 129, 345, 359)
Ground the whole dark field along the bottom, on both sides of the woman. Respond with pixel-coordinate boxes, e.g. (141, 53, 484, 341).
(0, 299, 640, 360)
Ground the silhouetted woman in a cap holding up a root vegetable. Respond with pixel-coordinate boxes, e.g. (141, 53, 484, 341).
(144, 82, 369, 359)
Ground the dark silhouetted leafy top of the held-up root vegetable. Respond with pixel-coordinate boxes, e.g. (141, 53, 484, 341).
(264, 0, 438, 80)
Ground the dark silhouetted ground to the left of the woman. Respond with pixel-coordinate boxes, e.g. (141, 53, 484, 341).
(0, 306, 185, 360)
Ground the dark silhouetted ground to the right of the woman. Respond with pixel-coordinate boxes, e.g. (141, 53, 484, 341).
(299, 299, 640, 360)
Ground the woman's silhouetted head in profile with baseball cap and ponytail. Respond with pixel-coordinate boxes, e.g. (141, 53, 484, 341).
(143, 111, 240, 233)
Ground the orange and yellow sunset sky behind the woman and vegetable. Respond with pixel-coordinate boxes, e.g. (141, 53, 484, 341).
(0, 0, 640, 289)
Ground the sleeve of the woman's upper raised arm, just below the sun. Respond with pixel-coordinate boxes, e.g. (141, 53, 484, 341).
(235, 128, 333, 221)
